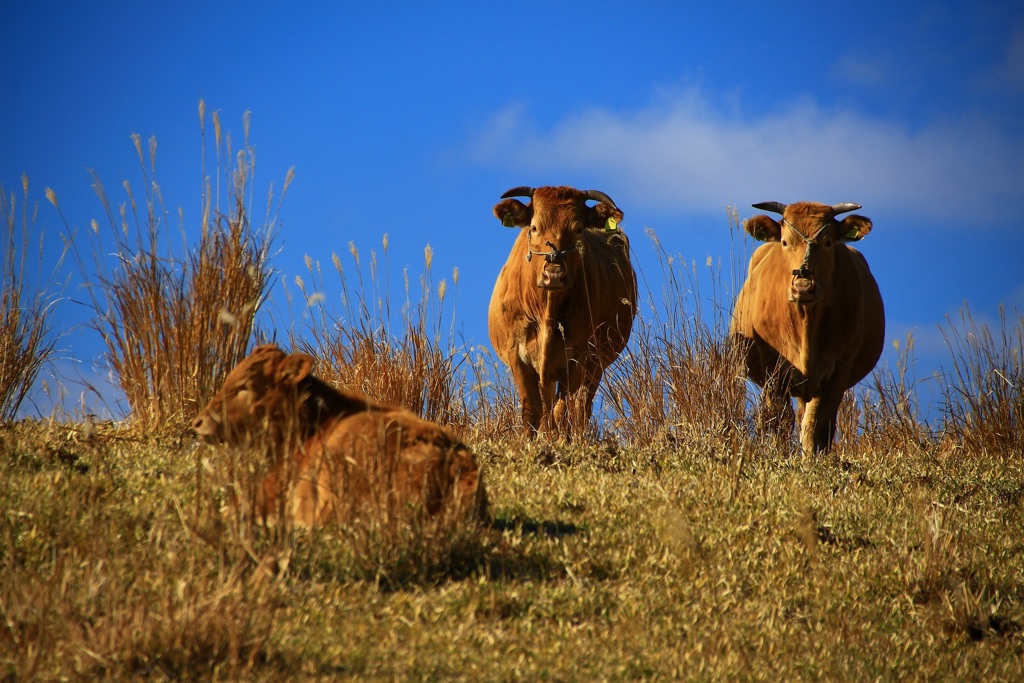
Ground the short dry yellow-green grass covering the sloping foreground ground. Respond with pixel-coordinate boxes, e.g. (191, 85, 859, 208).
(0, 423, 1024, 680)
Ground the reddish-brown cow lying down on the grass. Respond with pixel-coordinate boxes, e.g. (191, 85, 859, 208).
(193, 344, 486, 526)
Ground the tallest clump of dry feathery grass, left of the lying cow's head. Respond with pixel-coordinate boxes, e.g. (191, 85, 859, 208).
(48, 101, 292, 431)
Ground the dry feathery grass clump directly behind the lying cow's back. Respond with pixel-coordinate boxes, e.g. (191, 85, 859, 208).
(293, 234, 520, 446)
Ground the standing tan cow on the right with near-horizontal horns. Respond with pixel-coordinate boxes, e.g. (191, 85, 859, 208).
(731, 202, 885, 453)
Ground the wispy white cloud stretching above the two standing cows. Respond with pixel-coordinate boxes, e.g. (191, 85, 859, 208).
(474, 89, 1024, 222)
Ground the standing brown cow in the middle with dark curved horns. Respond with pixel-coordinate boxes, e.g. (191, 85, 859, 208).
(487, 187, 637, 435)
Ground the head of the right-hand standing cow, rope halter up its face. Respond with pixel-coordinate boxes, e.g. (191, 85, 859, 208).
(744, 202, 871, 306)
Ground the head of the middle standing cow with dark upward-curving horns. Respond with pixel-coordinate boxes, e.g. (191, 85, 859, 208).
(495, 187, 623, 291)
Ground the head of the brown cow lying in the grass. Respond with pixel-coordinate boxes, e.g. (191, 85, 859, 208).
(193, 344, 313, 445)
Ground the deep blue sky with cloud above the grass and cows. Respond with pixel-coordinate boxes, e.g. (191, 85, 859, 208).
(0, 0, 1024, 421)
